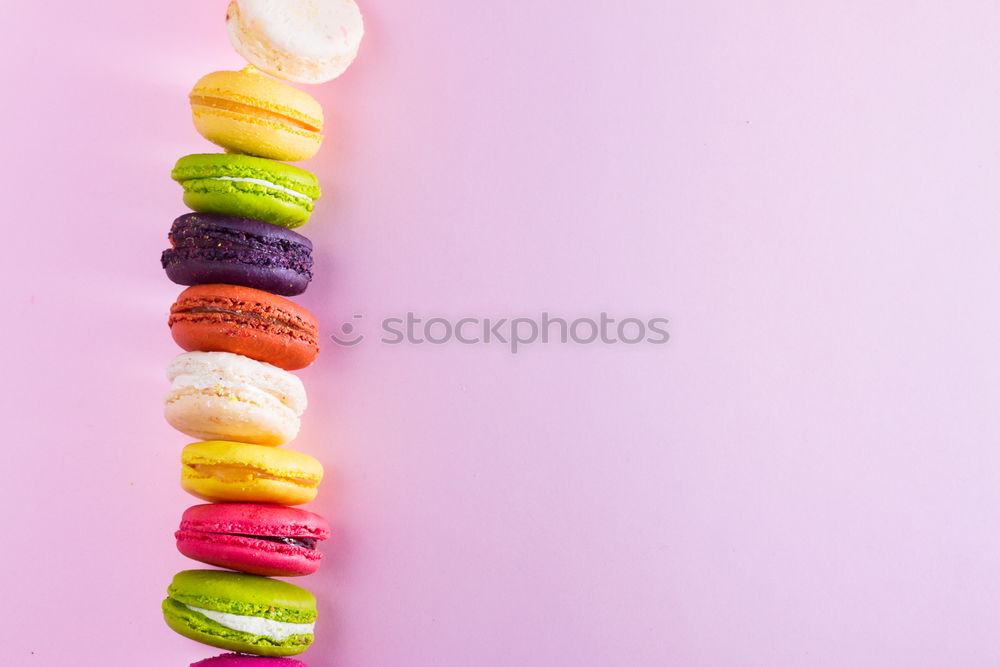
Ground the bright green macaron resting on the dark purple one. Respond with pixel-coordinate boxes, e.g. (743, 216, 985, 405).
(170, 153, 320, 228)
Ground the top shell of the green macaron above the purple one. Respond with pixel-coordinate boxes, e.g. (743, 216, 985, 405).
(170, 153, 320, 202)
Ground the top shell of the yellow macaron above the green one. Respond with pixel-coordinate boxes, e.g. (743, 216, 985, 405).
(189, 67, 323, 134)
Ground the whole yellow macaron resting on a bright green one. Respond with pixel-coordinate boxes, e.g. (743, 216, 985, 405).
(189, 67, 323, 162)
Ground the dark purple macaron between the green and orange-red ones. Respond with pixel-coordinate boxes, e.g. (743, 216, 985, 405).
(160, 213, 312, 296)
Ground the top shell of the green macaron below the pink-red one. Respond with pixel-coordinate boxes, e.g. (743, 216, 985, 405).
(167, 570, 316, 623)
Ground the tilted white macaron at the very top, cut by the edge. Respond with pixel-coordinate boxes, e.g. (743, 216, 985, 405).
(226, 0, 365, 83)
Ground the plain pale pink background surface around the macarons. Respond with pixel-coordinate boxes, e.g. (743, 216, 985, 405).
(0, 0, 1000, 667)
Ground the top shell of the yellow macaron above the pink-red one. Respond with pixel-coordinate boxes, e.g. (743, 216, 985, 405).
(181, 440, 323, 487)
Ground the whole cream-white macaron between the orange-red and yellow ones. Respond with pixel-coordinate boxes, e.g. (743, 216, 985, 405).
(163, 352, 307, 446)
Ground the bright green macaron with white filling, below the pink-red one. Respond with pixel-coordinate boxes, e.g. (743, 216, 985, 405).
(163, 570, 316, 656)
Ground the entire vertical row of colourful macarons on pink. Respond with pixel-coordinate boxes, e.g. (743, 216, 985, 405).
(161, 0, 364, 667)
